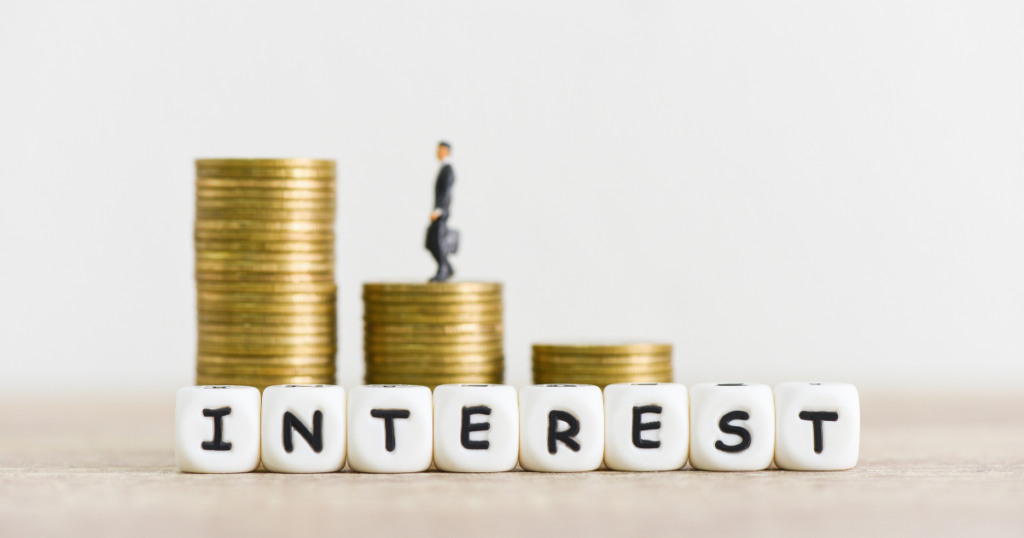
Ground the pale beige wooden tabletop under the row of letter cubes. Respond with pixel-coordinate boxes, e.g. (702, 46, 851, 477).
(0, 392, 1024, 538)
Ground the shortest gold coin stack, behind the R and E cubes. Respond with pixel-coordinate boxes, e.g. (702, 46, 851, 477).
(534, 342, 672, 388)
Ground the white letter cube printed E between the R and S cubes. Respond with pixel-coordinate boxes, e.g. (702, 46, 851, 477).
(604, 383, 690, 470)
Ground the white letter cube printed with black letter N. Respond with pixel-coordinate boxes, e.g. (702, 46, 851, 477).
(260, 385, 345, 472)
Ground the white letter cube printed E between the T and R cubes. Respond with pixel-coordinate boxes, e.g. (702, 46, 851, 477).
(434, 384, 519, 472)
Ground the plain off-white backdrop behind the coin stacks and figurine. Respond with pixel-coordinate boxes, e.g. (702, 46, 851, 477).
(0, 0, 1024, 389)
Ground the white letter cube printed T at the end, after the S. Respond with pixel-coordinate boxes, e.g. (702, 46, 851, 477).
(775, 382, 860, 470)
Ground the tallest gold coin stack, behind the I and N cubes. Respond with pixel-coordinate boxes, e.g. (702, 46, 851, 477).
(196, 159, 338, 389)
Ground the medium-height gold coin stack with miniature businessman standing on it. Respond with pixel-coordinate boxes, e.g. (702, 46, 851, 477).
(362, 282, 505, 388)
